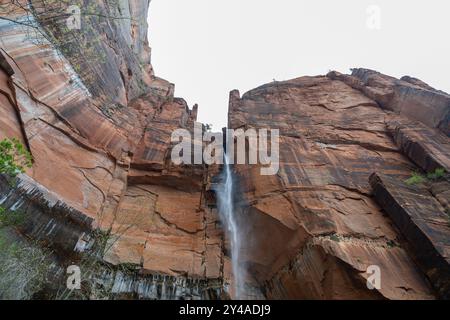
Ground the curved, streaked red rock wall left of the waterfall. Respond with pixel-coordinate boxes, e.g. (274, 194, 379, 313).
(0, 0, 224, 298)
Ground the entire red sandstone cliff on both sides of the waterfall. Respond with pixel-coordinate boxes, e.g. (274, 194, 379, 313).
(0, 0, 450, 299)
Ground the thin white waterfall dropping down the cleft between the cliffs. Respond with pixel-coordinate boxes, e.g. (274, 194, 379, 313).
(217, 155, 243, 299)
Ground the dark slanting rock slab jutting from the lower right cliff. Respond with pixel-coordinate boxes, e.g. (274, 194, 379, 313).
(370, 174, 450, 299)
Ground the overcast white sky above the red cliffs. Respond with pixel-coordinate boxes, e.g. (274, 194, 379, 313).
(149, 0, 450, 130)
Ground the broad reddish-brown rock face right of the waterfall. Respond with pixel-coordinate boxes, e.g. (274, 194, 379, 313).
(229, 75, 450, 299)
